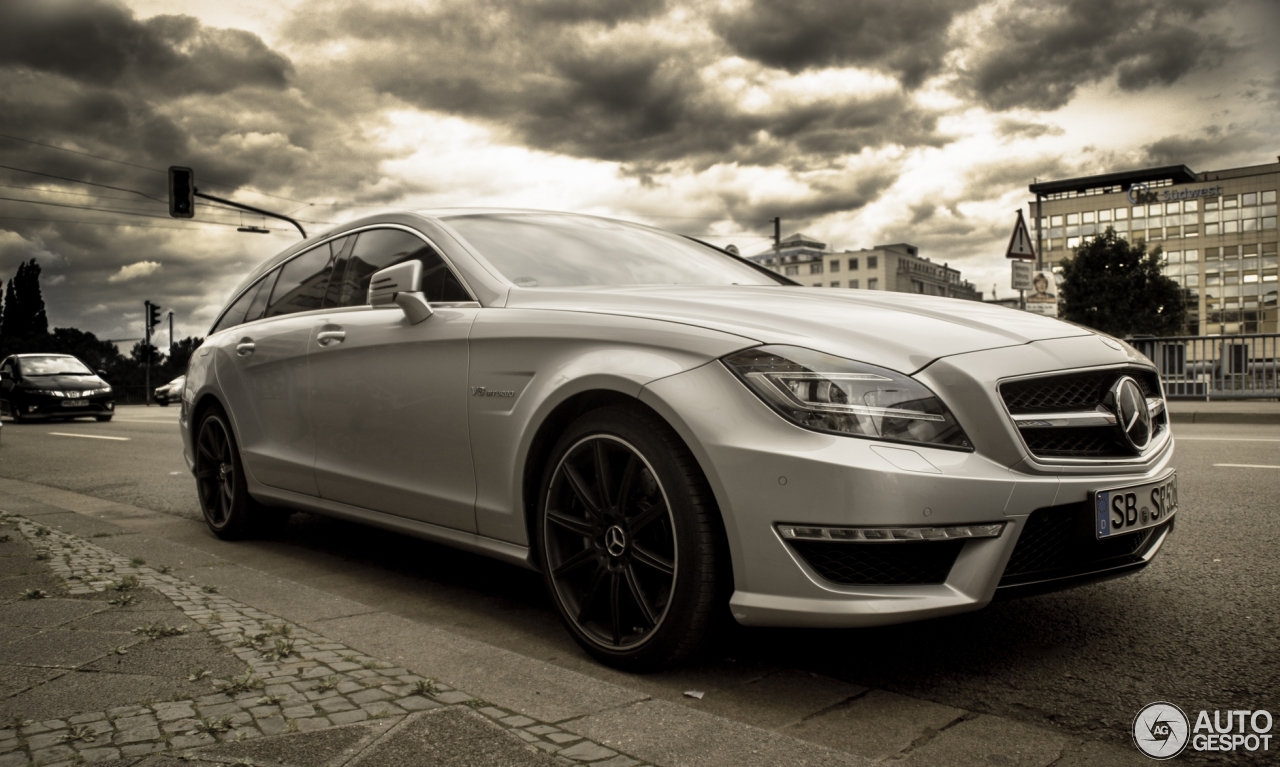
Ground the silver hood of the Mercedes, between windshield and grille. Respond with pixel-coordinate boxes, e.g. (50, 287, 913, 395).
(507, 286, 1093, 373)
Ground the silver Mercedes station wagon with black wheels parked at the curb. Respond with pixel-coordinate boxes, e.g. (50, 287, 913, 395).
(180, 210, 1178, 670)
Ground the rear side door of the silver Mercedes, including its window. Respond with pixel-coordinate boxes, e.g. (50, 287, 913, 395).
(215, 243, 334, 496)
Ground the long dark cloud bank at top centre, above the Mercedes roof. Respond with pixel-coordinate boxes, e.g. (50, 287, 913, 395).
(291, 0, 943, 173)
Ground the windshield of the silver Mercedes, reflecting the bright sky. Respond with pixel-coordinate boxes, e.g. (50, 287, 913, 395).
(444, 213, 788, 288)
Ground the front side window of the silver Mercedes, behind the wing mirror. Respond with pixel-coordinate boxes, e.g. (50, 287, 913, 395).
(338, 229, 471, 306)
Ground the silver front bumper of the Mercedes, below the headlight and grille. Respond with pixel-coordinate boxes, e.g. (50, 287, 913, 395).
(641, 344, 1174, 626)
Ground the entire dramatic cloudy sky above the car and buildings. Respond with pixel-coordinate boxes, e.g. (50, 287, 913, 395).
(0, 0, 1280, 338)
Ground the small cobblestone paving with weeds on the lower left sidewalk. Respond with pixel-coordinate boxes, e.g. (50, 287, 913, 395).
(0, 512, 643, 767)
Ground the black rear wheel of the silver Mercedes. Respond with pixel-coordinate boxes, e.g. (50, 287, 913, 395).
(195, 406, 289, 540)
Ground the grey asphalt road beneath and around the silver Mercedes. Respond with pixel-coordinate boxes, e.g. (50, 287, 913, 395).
(0, 407, 1280, 740)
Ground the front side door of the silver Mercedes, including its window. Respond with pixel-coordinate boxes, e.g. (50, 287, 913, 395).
(310, 228, 479, 531)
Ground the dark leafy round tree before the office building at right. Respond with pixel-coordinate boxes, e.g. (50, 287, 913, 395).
(1059, 228, 1187, 338)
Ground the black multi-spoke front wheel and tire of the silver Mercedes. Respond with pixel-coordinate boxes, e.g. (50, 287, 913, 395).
(538, 407, 722, 671)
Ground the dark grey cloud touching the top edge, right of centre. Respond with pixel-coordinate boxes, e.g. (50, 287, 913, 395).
(714, 0, 977, 87)
